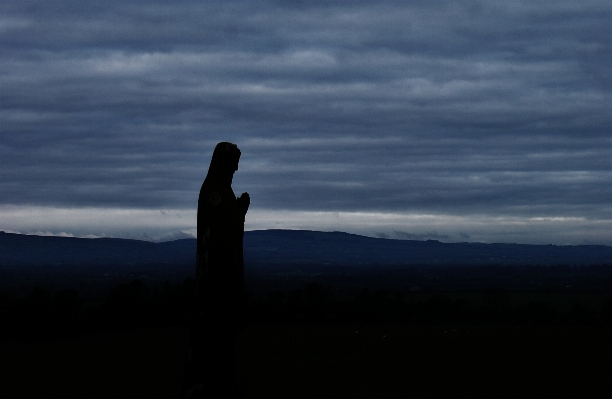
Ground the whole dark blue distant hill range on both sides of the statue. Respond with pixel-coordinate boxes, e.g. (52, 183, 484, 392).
(0, 230, 612, 266)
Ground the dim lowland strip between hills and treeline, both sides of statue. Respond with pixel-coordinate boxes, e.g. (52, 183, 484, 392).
(0, 263, 612, 300)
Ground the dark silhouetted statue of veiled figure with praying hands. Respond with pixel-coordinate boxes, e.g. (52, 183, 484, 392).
(184, 142, 250, 398)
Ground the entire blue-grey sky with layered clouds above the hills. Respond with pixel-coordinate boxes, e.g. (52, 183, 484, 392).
(0, 0, 612, 245)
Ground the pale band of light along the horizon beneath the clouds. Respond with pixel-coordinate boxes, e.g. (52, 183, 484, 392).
(0, 205, 612, 245)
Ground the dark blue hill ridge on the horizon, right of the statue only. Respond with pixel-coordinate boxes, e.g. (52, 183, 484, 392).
(245, 230, 612, 265)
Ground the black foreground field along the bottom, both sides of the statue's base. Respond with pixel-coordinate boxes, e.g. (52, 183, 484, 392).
(0, 323, 612, 399)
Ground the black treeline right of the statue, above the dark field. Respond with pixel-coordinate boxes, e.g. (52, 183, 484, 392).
(247, 282, 612, 325)
